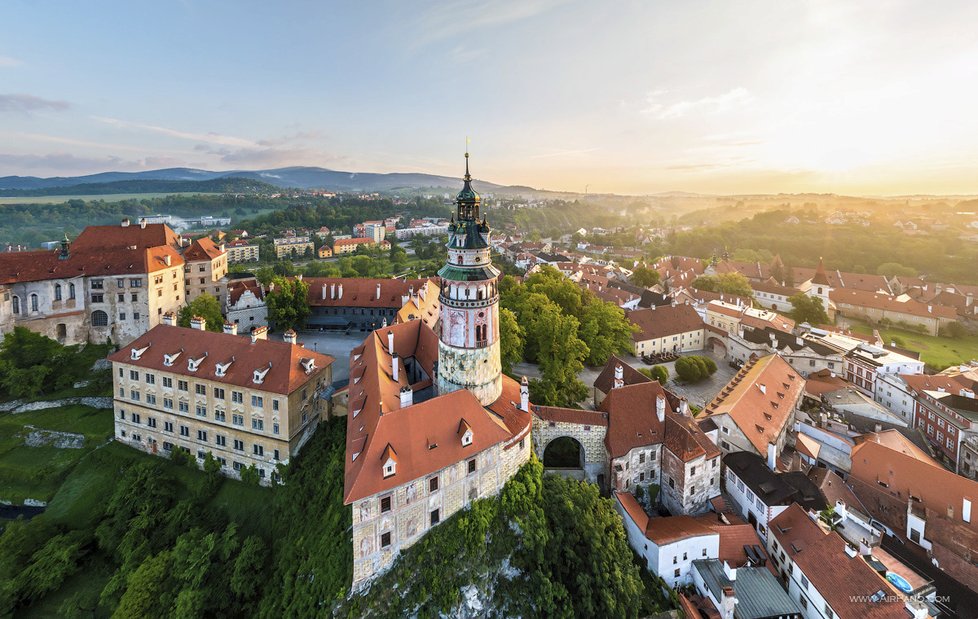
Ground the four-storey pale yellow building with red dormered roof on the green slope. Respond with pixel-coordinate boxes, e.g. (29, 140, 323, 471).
(109, 314, 333, 483)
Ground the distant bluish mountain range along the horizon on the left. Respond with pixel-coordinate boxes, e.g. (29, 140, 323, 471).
(0, 167, 520, 196)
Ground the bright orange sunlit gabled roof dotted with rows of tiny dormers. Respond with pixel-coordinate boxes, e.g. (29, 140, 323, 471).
(703, 355, 805, 454)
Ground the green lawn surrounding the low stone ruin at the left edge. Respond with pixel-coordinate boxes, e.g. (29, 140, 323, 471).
(0, 406, 113, 503)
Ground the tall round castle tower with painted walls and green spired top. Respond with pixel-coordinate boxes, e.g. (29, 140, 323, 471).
(436, 153, 503, 406)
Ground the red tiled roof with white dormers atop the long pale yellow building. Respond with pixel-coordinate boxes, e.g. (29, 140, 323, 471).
(108, 325, 333, 395)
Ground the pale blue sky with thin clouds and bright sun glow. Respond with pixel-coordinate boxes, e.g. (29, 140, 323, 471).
(0, 0, 978, 195)
